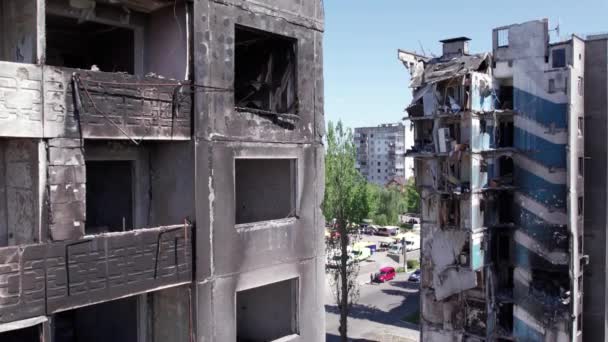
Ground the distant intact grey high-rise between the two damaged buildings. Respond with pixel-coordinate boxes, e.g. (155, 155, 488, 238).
(355, 123, 413, 185)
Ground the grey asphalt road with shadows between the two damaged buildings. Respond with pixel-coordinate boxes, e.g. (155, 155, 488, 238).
(325, 236, 420, 342)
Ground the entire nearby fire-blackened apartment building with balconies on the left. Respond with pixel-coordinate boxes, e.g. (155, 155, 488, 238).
(0, 0, 325, 342)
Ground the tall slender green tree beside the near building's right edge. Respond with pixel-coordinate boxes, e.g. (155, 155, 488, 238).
(322, 121, 370, 342)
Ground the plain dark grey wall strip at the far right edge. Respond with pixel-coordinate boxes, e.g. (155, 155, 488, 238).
(583, 37, 608, 341)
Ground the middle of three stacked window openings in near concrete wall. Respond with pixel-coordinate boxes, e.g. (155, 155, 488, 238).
(234, 158, 297, 224)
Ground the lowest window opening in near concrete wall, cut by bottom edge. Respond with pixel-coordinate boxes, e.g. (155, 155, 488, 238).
(236, 278, 299, 342)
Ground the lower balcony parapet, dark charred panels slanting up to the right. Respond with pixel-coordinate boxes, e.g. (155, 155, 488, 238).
(0, 224, 192, 323)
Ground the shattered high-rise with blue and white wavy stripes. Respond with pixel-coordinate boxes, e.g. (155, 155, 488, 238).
(399, 20, 588, 341)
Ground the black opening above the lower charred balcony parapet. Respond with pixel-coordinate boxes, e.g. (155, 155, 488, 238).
(85, 160, 134, 234)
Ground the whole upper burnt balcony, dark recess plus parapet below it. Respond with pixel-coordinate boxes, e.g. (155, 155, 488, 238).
(0, 0, 195, 141)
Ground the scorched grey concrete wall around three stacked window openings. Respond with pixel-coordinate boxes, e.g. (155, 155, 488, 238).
(193, 0, 325, 341)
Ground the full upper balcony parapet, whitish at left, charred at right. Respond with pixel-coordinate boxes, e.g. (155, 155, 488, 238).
(0, 62, 192, 141)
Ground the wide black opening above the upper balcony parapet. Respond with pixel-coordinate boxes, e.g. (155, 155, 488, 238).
(46, 14, 135, 74)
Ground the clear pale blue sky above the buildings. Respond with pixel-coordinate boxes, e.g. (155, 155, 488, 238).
(324, 0, 608, 127)
